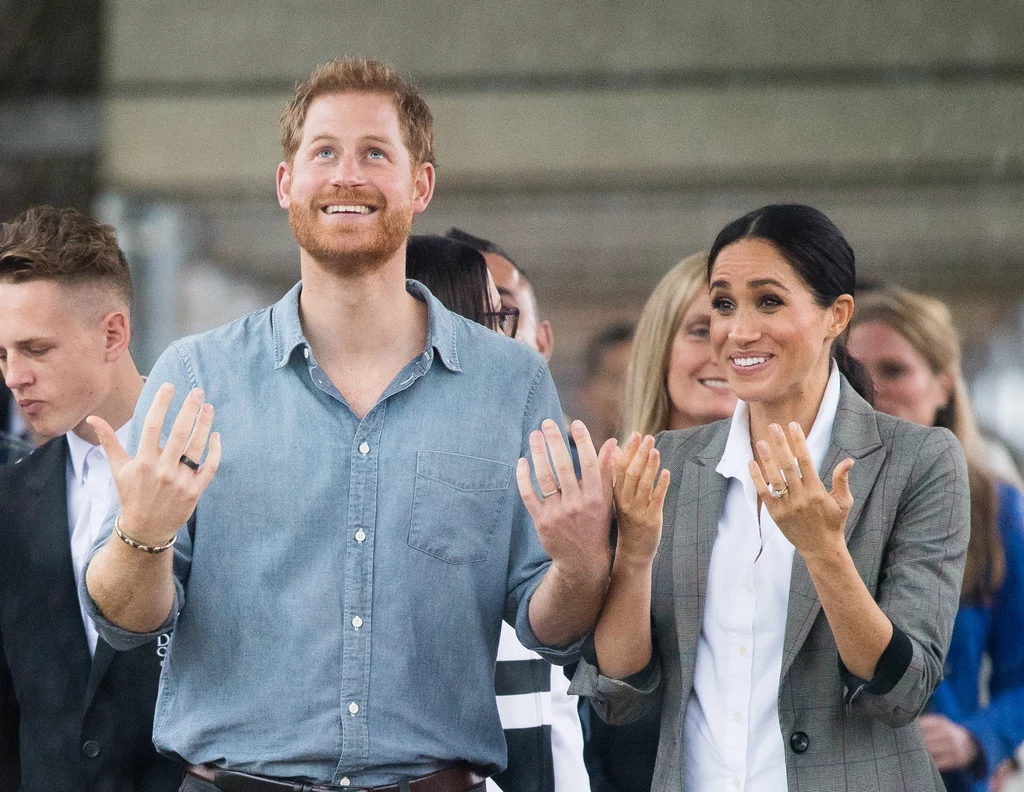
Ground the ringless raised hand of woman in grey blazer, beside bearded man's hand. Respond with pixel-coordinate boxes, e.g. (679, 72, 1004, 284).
(613, 431, 670, 564)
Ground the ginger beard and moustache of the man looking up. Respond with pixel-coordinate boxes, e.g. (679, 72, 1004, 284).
(288, 193, 413, 277)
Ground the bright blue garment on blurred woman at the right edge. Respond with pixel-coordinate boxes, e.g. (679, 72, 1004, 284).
(929, 482, 1024, 792)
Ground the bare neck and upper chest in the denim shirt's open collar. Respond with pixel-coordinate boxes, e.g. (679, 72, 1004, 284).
(299, 245, 427, 417)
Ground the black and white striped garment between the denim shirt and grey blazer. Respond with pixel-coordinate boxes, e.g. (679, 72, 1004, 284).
(487, 623, 590, 792)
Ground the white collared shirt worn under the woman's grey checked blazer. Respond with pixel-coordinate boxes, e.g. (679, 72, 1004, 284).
(683, 364, 840, 792)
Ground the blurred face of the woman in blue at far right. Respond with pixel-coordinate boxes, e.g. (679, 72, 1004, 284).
(849, 322, 952, 426)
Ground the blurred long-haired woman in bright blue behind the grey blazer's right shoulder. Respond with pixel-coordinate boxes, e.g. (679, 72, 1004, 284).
(850, 289, 1024, 792)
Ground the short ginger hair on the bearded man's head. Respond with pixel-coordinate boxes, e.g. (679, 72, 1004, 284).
(281, 57, 434, 166)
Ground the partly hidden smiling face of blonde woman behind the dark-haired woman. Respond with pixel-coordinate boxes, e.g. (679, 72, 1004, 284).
(667, 288, 736, 429)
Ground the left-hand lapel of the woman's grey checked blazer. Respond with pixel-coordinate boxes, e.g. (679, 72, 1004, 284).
(672, 421, 729, 690)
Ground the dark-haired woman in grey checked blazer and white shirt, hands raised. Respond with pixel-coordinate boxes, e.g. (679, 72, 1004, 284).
(573, 205, 970, 792)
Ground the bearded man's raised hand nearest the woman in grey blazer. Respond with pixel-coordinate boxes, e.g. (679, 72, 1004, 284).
(515, 418, 615, 572)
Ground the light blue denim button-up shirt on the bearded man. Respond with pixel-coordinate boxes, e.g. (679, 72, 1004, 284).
(83, 281, 578, 785)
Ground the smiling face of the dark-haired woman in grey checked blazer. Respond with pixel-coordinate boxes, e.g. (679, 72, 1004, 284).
(711, 239, 853, 406)
